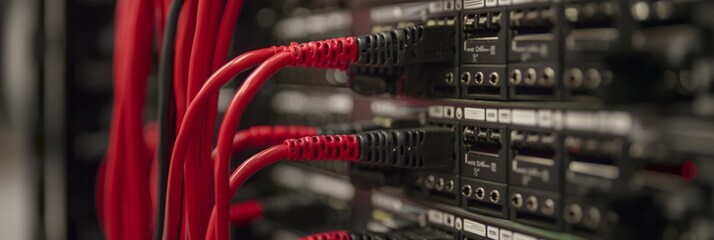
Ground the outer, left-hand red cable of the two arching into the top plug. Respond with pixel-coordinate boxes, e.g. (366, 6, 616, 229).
(163, 48, 277, 240)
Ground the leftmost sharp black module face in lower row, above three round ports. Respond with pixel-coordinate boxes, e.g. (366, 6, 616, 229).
(460, 123, 509, 183)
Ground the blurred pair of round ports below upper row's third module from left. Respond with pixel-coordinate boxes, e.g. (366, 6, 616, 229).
(563, 68, 613, 89)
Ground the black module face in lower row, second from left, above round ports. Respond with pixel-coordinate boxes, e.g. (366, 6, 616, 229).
(509, 127, 563, 191)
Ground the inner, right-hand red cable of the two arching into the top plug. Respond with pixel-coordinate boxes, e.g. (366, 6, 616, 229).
(209, 52, 292, 239)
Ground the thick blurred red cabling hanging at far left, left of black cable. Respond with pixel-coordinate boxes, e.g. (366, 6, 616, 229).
(103, 0, 154, 239)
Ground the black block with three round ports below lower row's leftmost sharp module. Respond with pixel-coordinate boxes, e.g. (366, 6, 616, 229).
(461, 178, 508, 218)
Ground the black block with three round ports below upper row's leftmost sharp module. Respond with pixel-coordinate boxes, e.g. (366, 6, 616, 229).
(459, 64, 508, 100)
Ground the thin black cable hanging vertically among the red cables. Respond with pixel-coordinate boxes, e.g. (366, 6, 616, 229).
(154, 0, 184, 240)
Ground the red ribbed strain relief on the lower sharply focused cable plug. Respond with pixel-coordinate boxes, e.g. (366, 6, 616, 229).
(284, 135, 360, 161)
